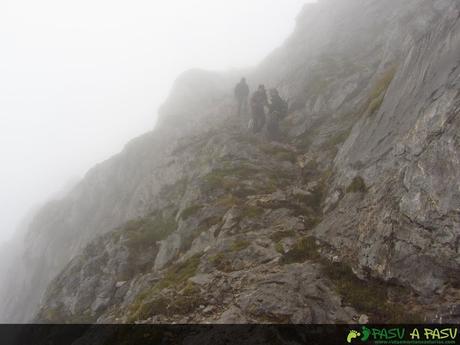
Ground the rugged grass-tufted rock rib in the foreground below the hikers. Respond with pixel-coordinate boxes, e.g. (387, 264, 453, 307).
(39, 129, 359, 323)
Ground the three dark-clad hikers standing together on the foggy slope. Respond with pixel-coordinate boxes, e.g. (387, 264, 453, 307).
(235, 78, 288, 140)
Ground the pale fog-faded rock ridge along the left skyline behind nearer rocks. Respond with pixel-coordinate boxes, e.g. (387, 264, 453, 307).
(0, 70, 234, 322)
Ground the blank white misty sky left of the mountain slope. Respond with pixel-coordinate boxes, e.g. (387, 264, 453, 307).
(0, 0, 314, 242)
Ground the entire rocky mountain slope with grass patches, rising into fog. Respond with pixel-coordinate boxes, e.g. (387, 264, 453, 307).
(1, 0, 460, 323)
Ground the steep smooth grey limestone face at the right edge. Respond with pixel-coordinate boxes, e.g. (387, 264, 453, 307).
(316, 3, 460, 297)
